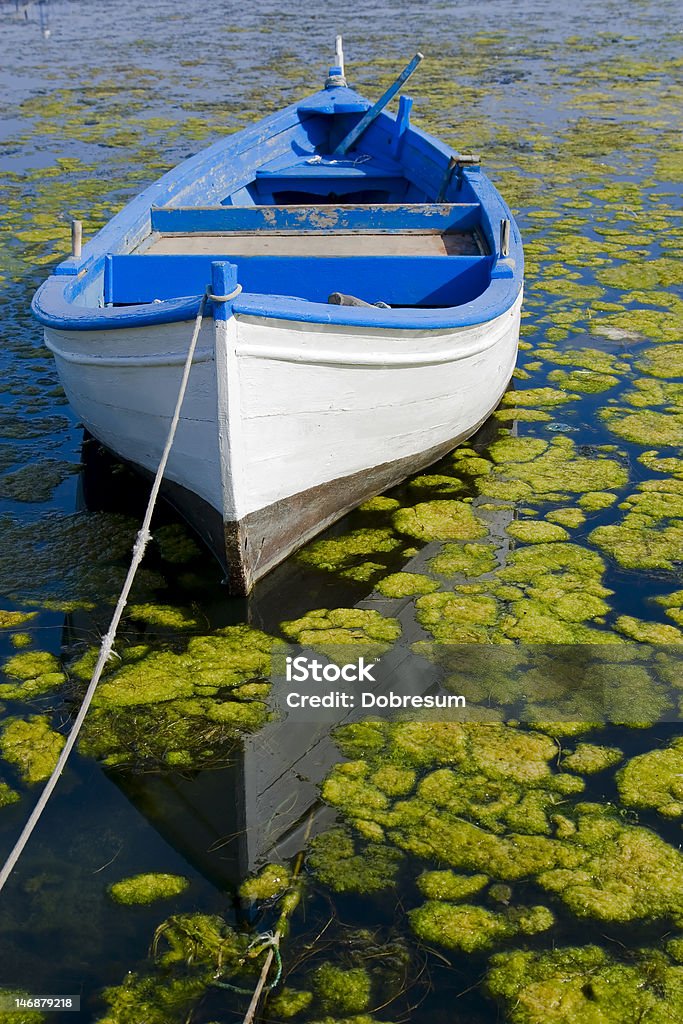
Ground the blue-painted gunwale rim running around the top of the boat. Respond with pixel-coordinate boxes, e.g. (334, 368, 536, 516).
(32, 87, 523, 331)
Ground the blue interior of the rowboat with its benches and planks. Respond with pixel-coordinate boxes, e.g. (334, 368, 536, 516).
(34, 76, 522, 328)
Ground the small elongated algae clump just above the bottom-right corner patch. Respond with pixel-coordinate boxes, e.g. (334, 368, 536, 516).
(409, 900, 555, 953)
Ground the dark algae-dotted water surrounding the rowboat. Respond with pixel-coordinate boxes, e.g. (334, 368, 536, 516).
(0, 0, 683, 1024)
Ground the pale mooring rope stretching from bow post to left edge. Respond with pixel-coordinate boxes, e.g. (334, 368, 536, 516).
(0, 292, 209, 891)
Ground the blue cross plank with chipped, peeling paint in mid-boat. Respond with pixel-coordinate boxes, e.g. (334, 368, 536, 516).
(152, 203, 480, 234)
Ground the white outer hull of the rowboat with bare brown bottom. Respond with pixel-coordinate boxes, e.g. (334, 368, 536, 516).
(45, 293, 522, 593)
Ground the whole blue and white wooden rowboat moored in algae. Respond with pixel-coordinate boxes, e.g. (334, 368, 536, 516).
(33, 46, 523, 594)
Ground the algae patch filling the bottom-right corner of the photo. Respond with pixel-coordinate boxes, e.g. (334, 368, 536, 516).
(484, 945, 683, 1024)
